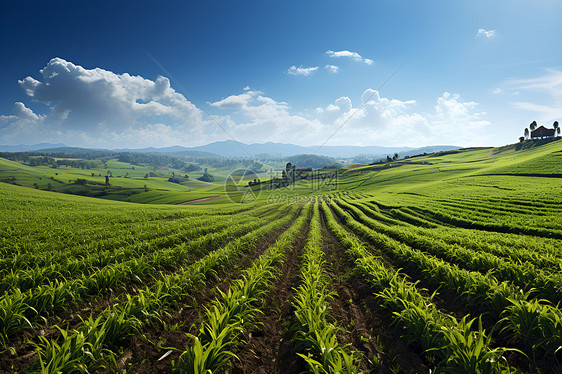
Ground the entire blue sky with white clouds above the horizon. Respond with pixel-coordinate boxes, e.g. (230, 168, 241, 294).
(0, 0, 562, 148)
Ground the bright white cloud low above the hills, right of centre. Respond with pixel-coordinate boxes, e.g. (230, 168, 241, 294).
(315, 89, 489, 146)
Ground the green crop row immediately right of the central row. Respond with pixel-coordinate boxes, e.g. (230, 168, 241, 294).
(322, 200, 506, 373)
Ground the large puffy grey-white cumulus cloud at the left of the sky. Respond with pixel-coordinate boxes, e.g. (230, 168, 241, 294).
(1, 58, 215, 147)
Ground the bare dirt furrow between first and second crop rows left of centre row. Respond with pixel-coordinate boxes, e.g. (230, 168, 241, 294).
(119, 206, 300, 374)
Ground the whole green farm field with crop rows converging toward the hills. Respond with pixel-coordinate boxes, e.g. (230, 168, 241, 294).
(0, 140, 562, 373)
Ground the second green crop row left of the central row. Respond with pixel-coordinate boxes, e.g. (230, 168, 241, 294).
(30, 205, 296, 373)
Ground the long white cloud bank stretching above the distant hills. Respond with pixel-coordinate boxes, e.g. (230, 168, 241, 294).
(0, 57, 488, 148)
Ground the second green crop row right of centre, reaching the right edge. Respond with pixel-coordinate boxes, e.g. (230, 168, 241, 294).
(332, 199, 562, 357)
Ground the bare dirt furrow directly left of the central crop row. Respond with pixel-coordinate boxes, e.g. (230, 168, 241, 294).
(232, 206, 310, 374)
